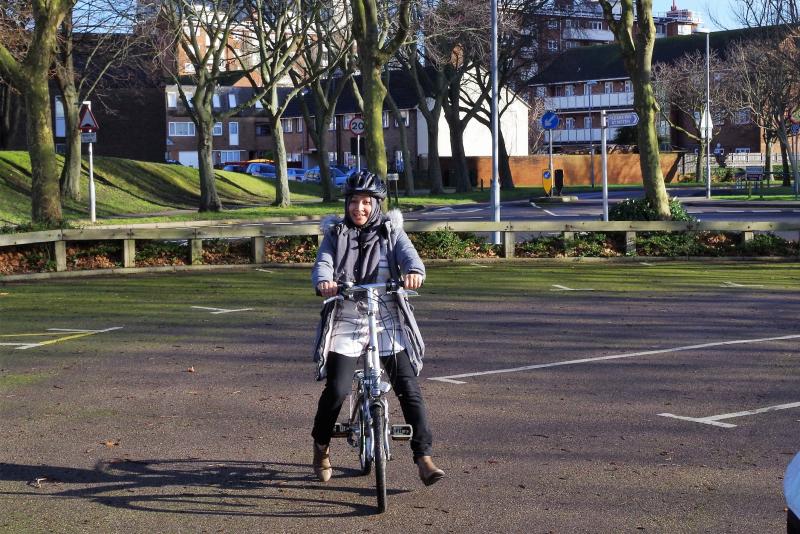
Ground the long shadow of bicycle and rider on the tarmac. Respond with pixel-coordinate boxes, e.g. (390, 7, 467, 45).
(0, 458, 408, 518)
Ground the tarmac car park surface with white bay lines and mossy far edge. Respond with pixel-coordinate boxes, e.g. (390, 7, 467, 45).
(0, 263, 800, 532)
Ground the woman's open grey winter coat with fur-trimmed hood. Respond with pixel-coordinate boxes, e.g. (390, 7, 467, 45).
(311, 210, 425, 380)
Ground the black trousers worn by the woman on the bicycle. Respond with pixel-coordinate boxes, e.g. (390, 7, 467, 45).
(311, 351, 433, 461)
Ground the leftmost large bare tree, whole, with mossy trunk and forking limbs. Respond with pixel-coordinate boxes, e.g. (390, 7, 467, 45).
(0, 0, 72, 222)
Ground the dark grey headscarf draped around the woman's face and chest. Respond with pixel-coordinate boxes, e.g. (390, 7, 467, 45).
(334, 196, 383, 284)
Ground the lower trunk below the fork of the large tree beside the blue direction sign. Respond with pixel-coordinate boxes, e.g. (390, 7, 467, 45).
(632, 76, 670, 220)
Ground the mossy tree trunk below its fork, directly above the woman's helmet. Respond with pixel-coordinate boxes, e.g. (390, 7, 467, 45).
(359, 62, 387, 176)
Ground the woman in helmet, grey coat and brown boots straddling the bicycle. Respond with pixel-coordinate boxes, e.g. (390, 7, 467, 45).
(311, 171, 444, 485)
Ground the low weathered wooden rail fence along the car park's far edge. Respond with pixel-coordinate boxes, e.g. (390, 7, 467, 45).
(0, 221, 800, 271)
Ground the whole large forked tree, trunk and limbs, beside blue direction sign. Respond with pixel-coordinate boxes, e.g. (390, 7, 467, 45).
(598, 0, 670, 219)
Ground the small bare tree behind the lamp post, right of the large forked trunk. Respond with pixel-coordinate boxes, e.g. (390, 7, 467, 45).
(653, 50, 736, 181)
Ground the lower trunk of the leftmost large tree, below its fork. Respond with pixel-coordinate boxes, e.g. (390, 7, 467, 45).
(25, 74, 62, 223)
